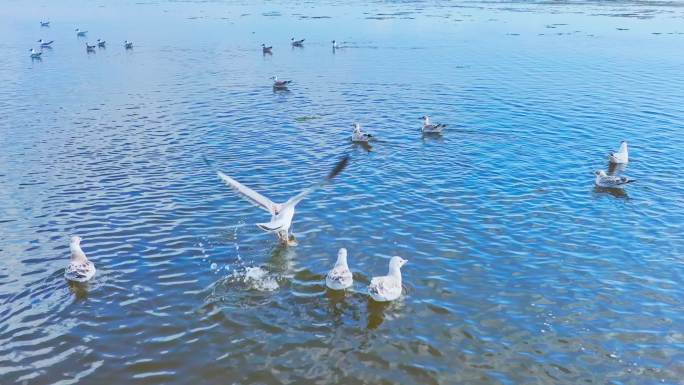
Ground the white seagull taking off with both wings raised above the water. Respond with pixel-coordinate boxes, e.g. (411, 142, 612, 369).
(211, 155, 349, 246)
